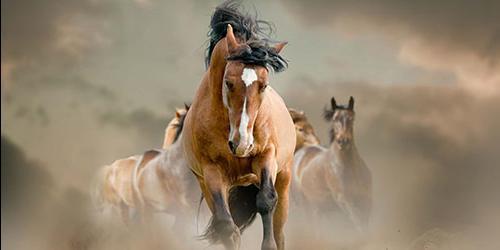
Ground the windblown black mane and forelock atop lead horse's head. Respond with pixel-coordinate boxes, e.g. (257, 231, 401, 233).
(205, 0, 288, 72)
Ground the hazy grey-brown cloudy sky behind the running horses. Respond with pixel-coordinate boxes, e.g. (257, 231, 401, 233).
(1, 0, 500, 249)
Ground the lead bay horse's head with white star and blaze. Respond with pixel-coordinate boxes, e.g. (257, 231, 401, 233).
(222, 25, 286, 157)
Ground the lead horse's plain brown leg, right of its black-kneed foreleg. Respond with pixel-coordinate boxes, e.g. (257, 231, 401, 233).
(273, 170, 291, 250)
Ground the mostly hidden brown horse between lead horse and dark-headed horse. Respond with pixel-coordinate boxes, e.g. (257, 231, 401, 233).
(288, 108, 320, 152)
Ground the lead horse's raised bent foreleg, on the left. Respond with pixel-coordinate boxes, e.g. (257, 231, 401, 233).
(201, 166, 240, 249)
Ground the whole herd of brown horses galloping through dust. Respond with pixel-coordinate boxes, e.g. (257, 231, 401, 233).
(93, 1, 372, 249)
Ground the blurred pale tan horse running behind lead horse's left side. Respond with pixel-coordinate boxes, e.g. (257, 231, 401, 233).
(94, 106, 194, 224)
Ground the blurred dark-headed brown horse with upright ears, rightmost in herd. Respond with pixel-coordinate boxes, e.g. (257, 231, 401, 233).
(293, 96, 372, 231)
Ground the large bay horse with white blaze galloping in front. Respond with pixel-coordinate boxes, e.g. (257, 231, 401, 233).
(182, 1, 295, 249)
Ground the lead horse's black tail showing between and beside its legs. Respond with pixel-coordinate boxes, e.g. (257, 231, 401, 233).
(201, 185, 259, 243)
